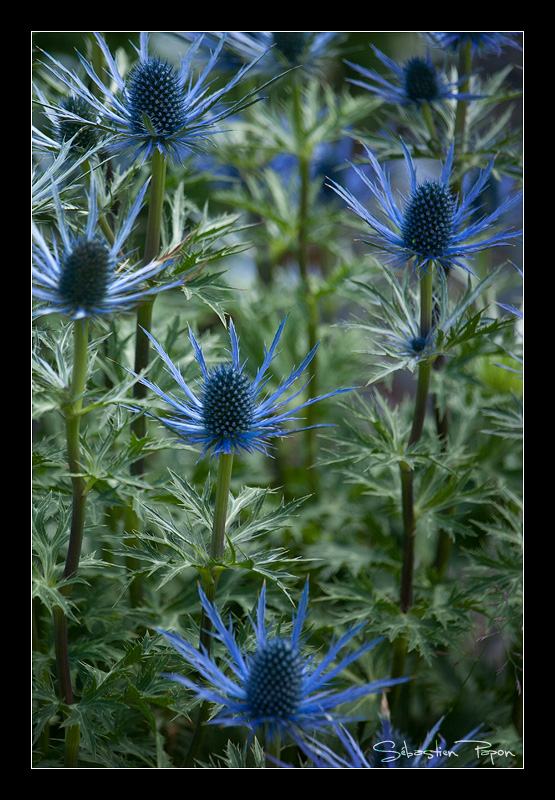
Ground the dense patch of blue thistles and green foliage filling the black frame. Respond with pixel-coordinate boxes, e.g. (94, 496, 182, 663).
(32, 31, 524, 769)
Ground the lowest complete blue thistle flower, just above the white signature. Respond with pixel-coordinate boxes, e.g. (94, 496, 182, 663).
(158, 581, 408, 741)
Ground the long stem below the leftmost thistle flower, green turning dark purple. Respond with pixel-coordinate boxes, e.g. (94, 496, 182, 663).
(53, 317, 88, 767)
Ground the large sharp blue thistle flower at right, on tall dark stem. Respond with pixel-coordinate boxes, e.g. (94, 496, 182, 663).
(331, 142, 520, 272)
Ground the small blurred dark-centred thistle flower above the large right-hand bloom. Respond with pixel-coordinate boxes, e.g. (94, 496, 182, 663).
(345, 45, 477, 106)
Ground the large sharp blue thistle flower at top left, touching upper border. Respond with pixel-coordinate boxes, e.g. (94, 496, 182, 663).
(40, 31, 282, 163)
